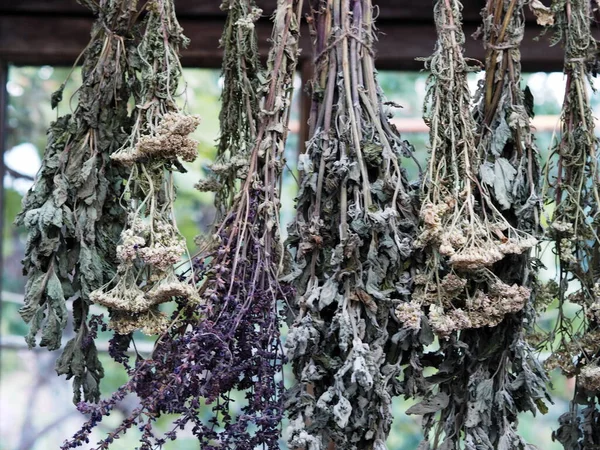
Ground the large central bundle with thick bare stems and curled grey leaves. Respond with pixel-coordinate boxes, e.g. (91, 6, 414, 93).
(286, 0, 422, 450)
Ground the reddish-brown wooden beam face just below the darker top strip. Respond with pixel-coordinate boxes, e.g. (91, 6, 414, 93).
(0, 13, 572, 71)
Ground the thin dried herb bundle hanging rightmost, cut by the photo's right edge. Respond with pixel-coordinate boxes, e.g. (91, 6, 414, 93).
(546, 0, 600, 450)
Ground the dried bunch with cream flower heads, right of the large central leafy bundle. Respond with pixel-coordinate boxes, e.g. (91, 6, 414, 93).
(406, 0, 536, 337)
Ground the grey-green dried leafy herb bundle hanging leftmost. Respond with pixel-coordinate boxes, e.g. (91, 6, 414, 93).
(16, 0, 137, 402)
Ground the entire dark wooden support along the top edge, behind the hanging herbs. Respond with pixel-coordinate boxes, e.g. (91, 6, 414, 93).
(0, 0, 584, 71)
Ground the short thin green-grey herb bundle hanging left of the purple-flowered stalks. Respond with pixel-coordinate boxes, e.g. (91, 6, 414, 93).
(197, 0, 262, 218)
